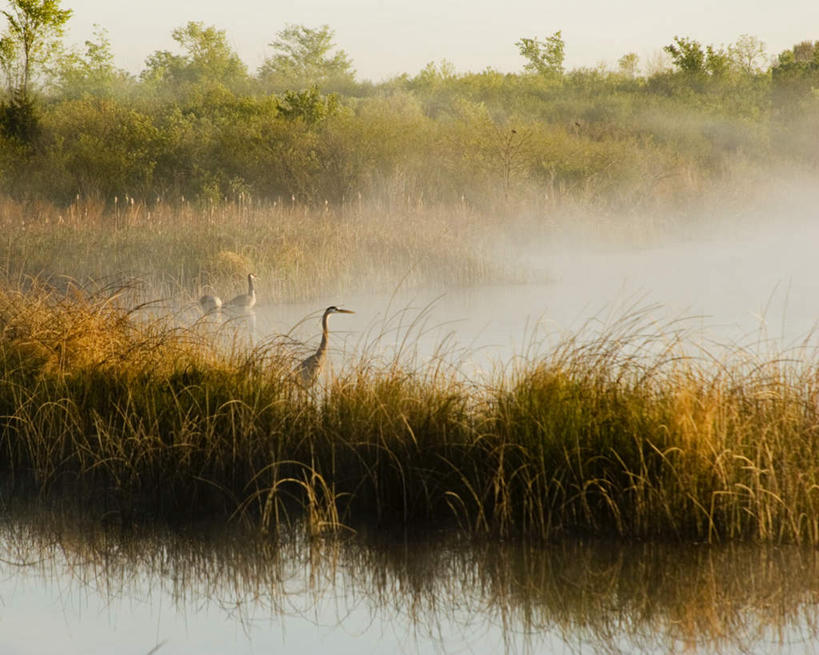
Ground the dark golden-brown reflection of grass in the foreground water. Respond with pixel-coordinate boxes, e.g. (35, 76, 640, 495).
(0, 511, 819, 652)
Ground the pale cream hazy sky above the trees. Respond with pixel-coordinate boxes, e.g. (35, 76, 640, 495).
(62, 0, 819, 81)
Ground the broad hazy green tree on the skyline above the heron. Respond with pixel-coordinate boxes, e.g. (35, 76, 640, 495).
(259, 25, 355, 91)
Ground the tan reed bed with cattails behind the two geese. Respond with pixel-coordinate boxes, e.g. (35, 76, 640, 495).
(0, 197, 523, 303)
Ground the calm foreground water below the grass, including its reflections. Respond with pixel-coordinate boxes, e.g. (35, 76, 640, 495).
(0, 512, 819, 655)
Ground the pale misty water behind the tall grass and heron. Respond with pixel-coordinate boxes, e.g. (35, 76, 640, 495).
(248, 204, 819, 380)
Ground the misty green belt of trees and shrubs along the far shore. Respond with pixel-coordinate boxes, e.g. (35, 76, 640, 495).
(0, 0, 819, 210)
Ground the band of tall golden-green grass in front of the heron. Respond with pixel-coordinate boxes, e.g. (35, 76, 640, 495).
(0, 288, 819, 544)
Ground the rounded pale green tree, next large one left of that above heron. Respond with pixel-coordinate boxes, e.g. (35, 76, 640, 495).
(142, 21, 248, 91)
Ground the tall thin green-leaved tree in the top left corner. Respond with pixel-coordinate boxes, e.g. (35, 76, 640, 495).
(0, 0, 72, 97)
